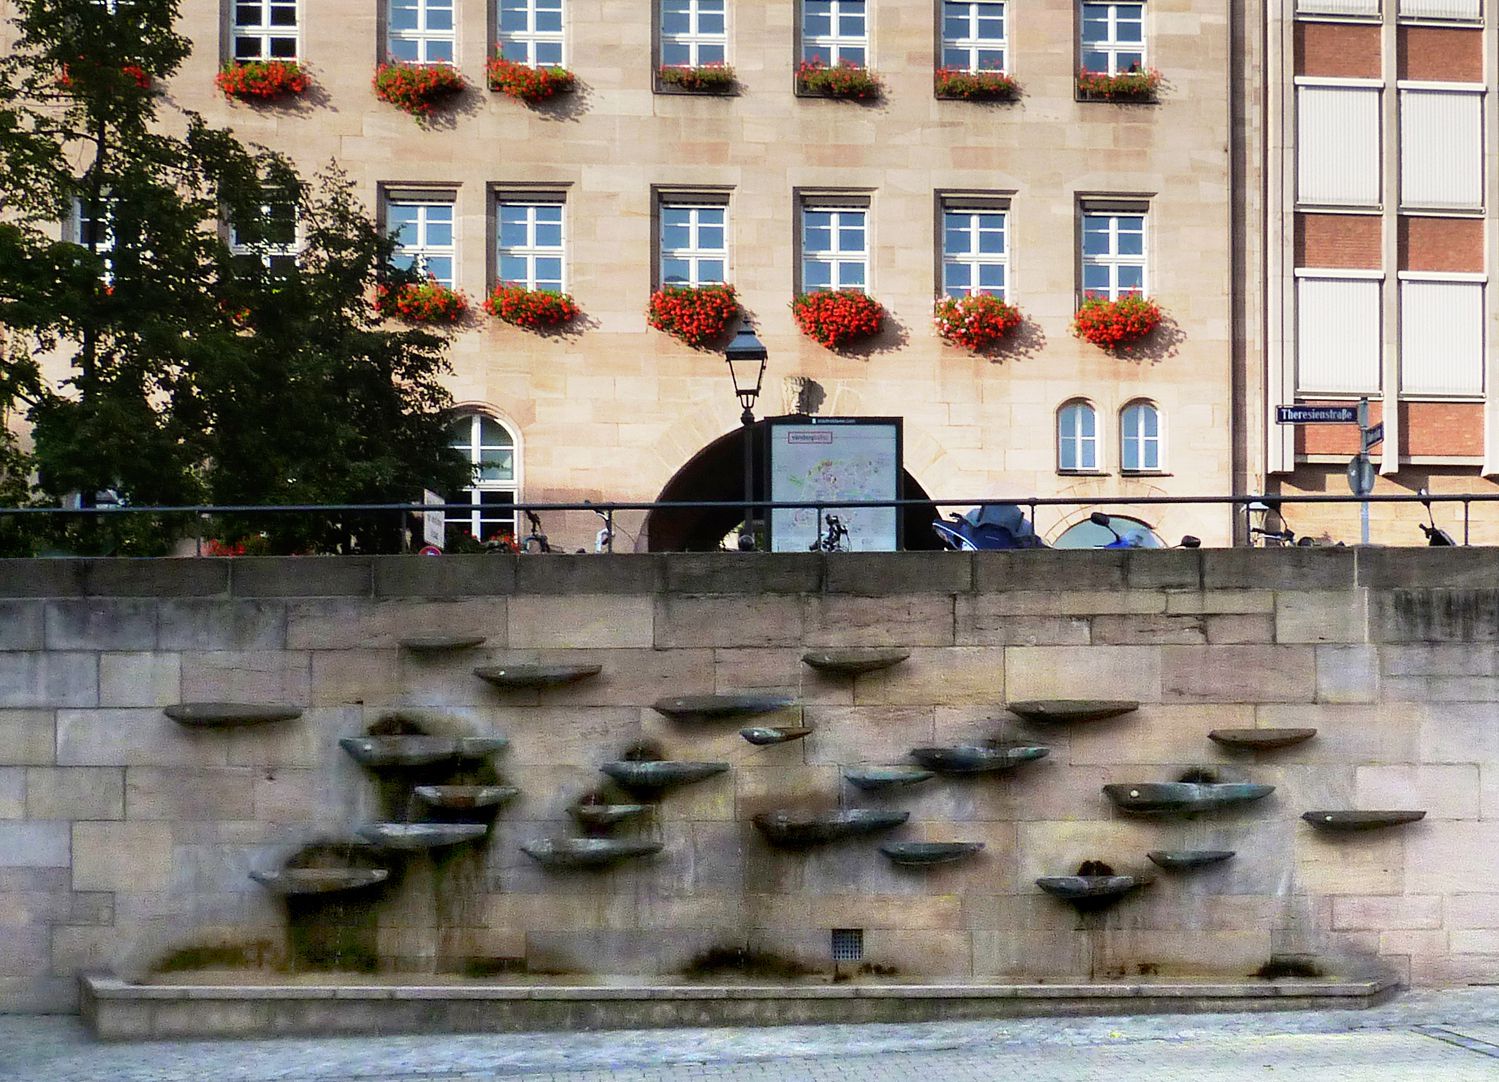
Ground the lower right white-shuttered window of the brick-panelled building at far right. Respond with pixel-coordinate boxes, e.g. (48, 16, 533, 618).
(1400, 282, 1484, 396)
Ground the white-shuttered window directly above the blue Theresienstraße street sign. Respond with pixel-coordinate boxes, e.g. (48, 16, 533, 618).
(1297, 271, 1381, 394)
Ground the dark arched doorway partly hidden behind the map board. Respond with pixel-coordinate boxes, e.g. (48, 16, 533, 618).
(645, 421, 941, 553)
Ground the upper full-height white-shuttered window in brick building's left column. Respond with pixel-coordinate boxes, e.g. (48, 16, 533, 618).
(1297, 87, 1381, 207)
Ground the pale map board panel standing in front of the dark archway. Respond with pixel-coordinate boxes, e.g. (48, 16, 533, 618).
(769, 417, 901, 553)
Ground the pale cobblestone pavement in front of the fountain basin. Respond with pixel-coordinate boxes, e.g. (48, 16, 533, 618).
(0, 989, 1499, 1082)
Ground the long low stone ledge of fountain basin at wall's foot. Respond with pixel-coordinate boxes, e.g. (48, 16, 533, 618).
(79, 974, 1396, 1040)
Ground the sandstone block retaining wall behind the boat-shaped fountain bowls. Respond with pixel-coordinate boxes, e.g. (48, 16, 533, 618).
(0, 548, 1499, 1010)
